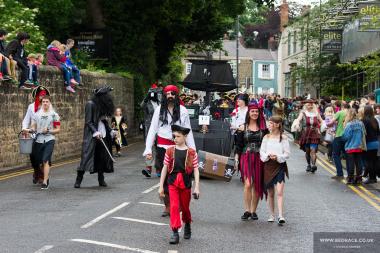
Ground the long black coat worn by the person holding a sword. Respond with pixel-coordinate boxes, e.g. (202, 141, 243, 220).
(77, 100, 114, 174)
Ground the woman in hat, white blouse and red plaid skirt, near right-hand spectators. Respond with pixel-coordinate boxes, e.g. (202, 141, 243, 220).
(297, 99, 323, 173)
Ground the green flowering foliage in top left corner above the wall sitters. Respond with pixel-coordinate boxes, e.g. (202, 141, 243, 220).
(0, 0, 46, 53)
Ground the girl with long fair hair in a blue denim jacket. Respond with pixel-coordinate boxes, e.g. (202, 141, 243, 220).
(342, 108, 366, 184)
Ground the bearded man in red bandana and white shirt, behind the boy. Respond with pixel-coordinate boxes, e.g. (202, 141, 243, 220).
(143, 85, 195, 216)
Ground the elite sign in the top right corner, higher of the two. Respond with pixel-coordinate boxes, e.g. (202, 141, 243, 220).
(358, 1, 380, 32)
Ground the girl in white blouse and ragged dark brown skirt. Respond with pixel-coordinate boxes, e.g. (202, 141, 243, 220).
(260, 116, 290, 225)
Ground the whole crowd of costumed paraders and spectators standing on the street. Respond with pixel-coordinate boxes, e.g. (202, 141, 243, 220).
(22, 80, 380, 244)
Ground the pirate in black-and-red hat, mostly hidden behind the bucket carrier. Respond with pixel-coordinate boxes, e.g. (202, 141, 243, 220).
(22, 85, 50, 184)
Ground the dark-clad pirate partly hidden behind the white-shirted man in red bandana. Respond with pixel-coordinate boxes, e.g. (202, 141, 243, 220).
(140, 83, 161, 177)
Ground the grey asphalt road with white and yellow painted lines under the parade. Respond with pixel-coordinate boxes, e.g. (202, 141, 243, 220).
(0, 139, 380, 253)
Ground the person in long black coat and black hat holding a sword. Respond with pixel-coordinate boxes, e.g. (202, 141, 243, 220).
(74, 86, 115, 188)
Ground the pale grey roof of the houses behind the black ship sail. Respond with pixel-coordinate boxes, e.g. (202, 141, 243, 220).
(213, 40, 277, 61)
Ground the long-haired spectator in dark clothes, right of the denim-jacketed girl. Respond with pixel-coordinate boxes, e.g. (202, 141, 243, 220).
(362, 105, 380, 184)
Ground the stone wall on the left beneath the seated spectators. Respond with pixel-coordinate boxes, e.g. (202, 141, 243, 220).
(0, 66, 138, 168)
